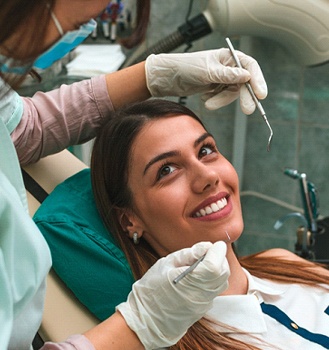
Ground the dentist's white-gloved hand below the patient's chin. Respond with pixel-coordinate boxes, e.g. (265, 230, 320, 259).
(117, 242, 230, 349)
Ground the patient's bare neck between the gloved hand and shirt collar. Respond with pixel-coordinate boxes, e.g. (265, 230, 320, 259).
(221, 244, 248, 295)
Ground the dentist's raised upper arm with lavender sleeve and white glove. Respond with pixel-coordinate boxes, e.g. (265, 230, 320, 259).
(9, 49, 267, 165)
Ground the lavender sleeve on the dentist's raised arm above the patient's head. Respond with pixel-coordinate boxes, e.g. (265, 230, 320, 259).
(11, 76, 113, 165)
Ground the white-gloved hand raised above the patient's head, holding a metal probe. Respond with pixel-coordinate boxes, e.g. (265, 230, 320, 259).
(145, 49, 267, 114)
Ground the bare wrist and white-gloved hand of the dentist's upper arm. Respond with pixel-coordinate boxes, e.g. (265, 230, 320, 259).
(106, 49, 267, 114)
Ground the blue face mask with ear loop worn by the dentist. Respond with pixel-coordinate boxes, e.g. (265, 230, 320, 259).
(0, 13, 97, 74)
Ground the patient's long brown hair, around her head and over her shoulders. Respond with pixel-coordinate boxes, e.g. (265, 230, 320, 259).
(91, 100, 328, 350)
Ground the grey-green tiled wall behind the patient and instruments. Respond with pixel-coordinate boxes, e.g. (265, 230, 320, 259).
(147, 0, 329, 253)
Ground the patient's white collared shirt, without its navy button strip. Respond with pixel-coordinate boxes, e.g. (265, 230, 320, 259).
(207, 270, 329, 350)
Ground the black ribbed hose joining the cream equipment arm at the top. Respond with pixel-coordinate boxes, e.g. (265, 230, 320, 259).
(124, 14, 212, 67)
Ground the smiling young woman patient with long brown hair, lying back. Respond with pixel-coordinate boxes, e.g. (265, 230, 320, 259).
(91, 100, 329, 350)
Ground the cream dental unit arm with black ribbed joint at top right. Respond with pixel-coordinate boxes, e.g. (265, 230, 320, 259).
(124, 0, 329, 66)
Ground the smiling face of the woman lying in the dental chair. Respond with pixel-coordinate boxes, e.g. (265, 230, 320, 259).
(128, 115, 243, 256)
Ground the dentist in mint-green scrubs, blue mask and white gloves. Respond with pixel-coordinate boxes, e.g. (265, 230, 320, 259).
(0, 0, 267, 350)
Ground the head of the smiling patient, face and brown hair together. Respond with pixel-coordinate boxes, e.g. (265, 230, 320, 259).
(92, 100, 243, 266)
